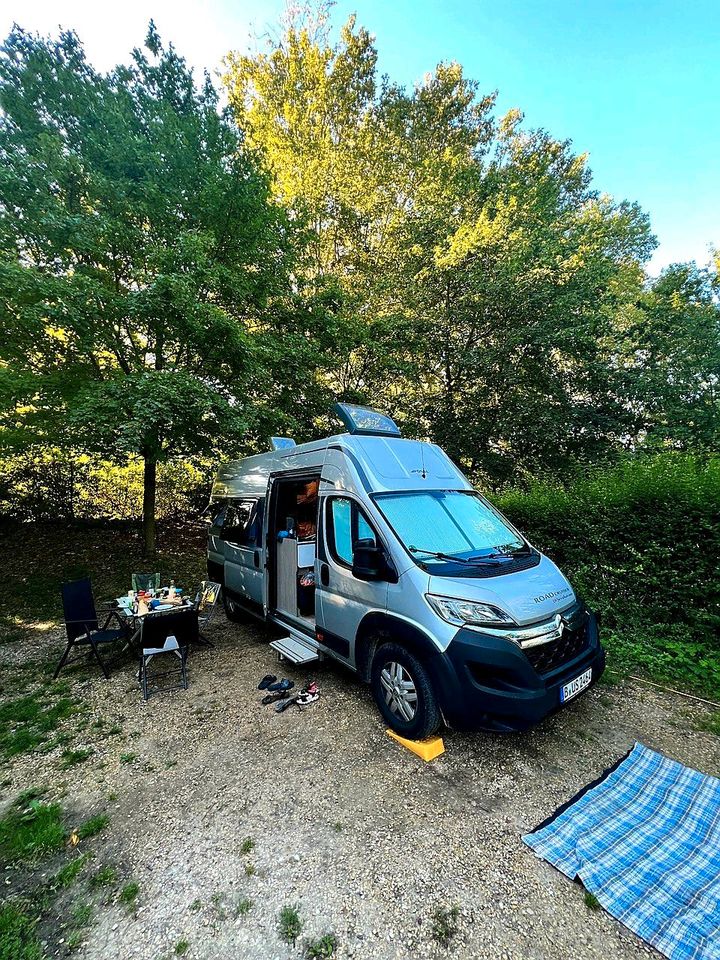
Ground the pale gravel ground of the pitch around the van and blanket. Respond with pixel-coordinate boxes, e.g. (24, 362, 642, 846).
(5, 612, 720, 960)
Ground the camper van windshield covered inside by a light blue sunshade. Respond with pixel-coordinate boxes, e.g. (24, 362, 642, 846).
(376, 490, 529, 563)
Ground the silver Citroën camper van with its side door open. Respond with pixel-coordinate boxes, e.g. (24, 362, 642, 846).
(208, 404, 605, 738)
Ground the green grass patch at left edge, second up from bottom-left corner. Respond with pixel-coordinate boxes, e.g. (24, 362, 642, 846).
(0, 791, 65, 863)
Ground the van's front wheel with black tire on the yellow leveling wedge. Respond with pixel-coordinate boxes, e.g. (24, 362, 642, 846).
(370, 643, 442, 740)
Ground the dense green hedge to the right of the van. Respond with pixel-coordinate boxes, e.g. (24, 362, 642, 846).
(494, 454, 720, 699)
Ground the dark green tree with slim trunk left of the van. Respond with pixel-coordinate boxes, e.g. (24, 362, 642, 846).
(0, 22, 294, 553)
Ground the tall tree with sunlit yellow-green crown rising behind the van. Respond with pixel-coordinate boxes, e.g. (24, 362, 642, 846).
(225, 5, 654, 483)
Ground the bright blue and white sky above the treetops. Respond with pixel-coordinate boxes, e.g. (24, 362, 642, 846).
(0, 0, 720, 271)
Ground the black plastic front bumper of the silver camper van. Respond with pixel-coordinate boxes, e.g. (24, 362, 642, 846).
(430, 610, 605, 731)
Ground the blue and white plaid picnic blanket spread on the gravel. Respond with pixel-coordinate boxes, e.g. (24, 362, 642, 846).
(523, 743, 720, 960)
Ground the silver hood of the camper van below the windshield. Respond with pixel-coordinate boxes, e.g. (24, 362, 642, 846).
(429, 555, 575, 626)
